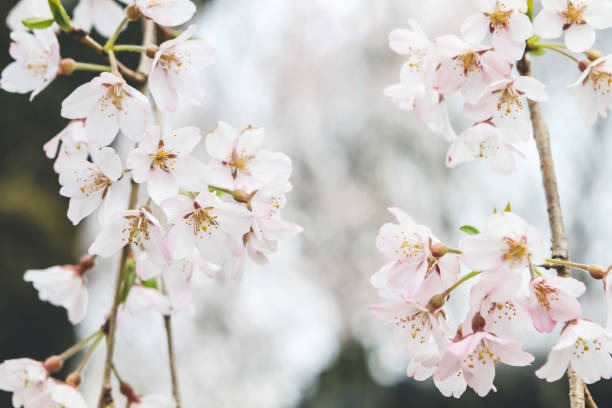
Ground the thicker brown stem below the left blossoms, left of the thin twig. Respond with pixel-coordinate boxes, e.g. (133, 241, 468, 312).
(98, 181, 138, 408)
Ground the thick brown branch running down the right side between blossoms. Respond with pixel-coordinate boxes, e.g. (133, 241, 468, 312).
(517, 55, 585, 408)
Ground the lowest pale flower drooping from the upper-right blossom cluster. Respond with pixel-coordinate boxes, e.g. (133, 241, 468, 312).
(446, 122, 523, 174)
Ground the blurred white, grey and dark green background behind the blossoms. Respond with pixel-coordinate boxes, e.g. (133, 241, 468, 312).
(0, 0, 612, 408)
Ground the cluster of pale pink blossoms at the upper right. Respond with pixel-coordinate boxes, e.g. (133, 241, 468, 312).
(384, 0, 612, 173)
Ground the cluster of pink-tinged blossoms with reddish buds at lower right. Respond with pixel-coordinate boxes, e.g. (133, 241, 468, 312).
(371, 208, 612, 398)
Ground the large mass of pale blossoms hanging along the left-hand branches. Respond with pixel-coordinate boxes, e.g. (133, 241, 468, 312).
(0, 0, 301, 408)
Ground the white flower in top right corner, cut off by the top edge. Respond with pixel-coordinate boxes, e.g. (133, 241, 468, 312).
(534, 0, 612, 52)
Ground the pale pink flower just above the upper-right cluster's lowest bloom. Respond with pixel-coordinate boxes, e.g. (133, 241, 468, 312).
(464, 76, 548, 143)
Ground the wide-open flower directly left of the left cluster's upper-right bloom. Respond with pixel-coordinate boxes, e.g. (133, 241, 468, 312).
(126, 126, 207, 204)
